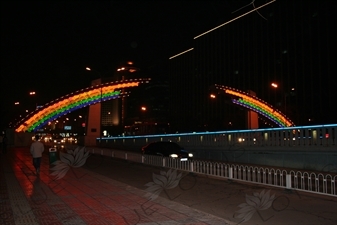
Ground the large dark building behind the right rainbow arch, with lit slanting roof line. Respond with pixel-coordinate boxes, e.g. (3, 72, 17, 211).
(168, 1, 337, 132)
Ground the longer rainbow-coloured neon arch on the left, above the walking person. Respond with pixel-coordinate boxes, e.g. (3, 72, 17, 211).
(15, 78, 149, 132)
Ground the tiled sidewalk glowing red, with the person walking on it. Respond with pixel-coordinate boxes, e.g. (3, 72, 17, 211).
(0, 148, 231, 225)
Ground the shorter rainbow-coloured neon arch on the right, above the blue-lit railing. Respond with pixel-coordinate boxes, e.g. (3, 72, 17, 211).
(215, 84, 294, 127)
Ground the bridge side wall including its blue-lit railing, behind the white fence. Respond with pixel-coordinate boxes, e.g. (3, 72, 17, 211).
(96, 124, 337, 172)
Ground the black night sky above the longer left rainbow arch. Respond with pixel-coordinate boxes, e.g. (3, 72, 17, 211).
(0, 0, 336, 130)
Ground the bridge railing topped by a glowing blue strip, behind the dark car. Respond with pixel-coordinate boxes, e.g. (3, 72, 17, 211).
(96, 124, 337, 150)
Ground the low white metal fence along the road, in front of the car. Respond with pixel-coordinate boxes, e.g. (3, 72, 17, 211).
(89, 148, 337, 197)
